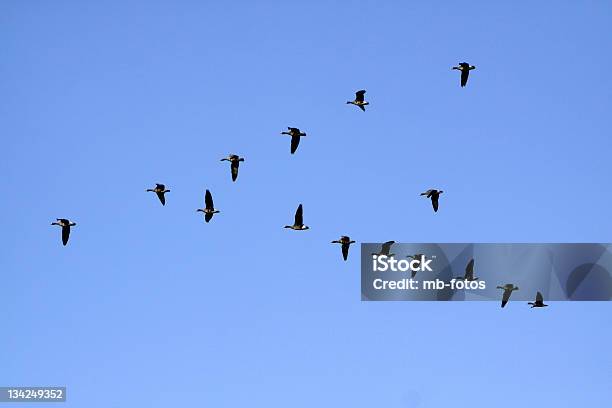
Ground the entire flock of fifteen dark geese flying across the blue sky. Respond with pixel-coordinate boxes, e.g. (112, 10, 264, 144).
(46, 62, 547, 307)
